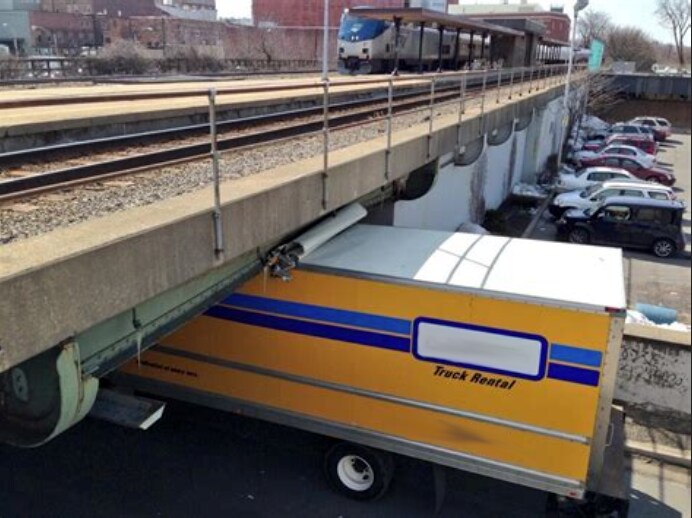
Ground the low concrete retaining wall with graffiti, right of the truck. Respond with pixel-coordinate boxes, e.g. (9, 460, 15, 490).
(615, 325, 692, 433)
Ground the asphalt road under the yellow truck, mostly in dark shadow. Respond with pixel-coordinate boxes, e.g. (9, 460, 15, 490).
(0, 402, 692, 518)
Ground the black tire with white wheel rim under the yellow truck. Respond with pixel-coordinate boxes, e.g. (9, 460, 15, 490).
(324, 442, 394, 501)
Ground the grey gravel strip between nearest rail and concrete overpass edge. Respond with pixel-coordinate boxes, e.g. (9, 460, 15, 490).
(0, 96, 484, 245)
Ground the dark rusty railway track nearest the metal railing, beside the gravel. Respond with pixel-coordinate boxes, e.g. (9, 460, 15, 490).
(0, 70, 564, 201)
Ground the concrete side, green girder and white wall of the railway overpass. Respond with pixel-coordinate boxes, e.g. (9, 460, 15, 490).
(0, 72, 563, 445)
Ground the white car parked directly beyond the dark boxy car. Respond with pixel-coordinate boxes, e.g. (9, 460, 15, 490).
(548, 180, 677, 218)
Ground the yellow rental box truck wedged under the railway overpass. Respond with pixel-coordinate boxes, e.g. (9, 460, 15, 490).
(118, 207, 626, 516)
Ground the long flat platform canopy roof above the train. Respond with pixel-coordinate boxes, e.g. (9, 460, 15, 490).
(347, 7, 524, 37)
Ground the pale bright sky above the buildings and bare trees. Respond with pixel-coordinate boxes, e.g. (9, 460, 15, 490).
(216, 0, 692, 45)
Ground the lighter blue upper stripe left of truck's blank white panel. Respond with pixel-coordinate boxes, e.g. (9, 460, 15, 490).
(222, 293, 411, 336)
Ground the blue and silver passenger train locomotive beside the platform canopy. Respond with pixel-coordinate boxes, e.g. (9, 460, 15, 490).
(338, 12, 481, 75)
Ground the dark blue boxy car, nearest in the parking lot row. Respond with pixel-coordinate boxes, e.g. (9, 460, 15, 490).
(558, 196, 685, 257)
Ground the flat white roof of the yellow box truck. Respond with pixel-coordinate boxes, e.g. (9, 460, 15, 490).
(301, 224, 627, 311)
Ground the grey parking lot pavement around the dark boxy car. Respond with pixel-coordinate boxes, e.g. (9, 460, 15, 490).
(531, 133, 692, 324)
